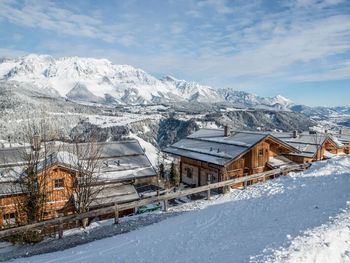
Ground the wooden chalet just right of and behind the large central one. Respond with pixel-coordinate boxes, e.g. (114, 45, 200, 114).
(272, 131, 345, 163)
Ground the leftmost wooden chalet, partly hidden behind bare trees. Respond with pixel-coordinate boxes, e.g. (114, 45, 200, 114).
(0, 140, 156, 227)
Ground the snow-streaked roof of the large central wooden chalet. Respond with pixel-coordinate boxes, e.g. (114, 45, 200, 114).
(164, 129, 297, 166)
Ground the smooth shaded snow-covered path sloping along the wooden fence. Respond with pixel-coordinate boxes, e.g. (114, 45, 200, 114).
(12, 157, 350, 263)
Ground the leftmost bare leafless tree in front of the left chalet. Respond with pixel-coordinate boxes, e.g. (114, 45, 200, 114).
(2, 118, 53, 229)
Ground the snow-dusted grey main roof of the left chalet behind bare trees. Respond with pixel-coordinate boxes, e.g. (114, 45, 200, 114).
(0, 140, 156, 194)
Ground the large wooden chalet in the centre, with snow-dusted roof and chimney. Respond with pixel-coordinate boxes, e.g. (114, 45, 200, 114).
(164, 127, 300, 190)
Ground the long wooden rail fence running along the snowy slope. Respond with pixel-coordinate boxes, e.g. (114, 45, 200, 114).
(0, 164, 310, 238)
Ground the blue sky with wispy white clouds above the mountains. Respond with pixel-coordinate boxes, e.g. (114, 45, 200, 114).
(0, 0, 350, 106)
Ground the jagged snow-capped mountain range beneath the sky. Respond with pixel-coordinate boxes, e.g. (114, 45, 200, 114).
(0, 54, 292, 109)
